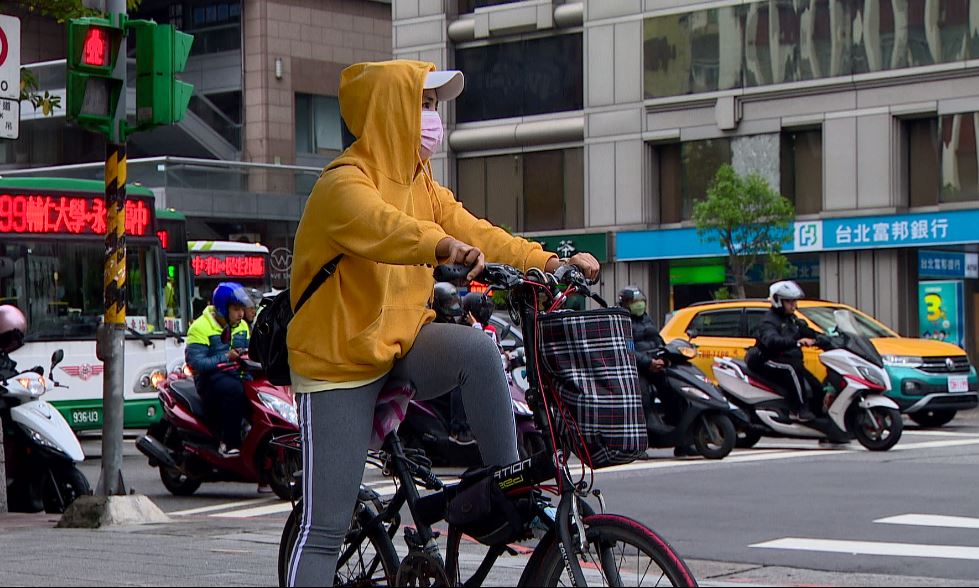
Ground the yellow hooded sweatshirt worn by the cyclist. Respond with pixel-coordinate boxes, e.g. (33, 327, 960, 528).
(288, 61, 555, 387)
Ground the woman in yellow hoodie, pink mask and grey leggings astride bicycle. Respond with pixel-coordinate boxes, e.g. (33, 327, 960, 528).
(288, 61, 599, 586)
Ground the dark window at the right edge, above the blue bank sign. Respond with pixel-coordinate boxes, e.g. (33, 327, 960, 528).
(904, 112, 979, 206)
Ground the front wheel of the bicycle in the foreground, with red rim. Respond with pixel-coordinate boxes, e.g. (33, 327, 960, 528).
(532, 515, 697, 586)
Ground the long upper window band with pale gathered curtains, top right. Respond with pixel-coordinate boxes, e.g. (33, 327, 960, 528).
(644, 0, 979, 98)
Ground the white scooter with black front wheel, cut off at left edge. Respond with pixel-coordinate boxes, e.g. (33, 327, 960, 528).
(0, 349, 92, 513)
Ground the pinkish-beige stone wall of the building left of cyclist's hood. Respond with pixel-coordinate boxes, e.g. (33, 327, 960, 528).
(242, 0, 392, 164)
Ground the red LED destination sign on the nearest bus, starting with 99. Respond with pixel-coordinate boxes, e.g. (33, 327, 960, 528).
(0, 194, 153, 237)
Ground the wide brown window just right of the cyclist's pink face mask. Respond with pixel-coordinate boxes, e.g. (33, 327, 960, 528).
(457, 148, 585, 232)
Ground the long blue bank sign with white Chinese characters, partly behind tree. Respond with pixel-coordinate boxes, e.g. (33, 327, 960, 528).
(615, 210, 979, 261)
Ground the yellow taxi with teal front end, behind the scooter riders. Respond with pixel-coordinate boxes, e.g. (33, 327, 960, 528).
(660, 300, 979, 427)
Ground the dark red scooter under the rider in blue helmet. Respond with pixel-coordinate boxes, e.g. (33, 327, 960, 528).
(136, 357, 302, 500)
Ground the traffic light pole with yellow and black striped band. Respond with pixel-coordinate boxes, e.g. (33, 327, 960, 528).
(97, 0, 126, 496)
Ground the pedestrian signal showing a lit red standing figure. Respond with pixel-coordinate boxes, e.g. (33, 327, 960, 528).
(65, 17, 125, 134)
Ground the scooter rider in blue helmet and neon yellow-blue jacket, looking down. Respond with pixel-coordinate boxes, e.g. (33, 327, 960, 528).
(184, 282, 253, 457)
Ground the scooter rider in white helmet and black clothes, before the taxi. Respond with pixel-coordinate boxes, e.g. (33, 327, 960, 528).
(745, 280, 824, 422)
